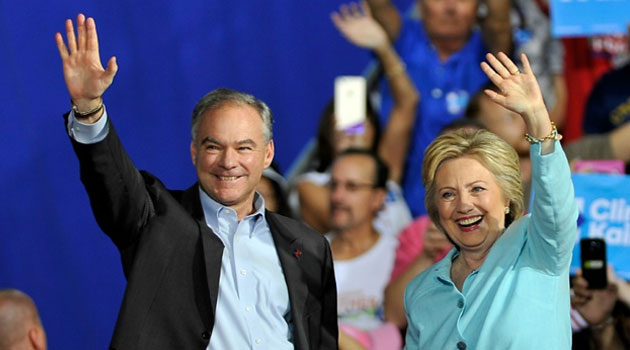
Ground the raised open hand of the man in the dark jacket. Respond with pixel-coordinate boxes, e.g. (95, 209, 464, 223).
(55, 14, 118, 111)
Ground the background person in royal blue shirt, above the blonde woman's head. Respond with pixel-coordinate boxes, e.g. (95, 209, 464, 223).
(368, 0, 512, 217)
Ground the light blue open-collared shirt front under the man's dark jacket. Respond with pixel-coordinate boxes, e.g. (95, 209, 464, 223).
(199, 191, 293, 350)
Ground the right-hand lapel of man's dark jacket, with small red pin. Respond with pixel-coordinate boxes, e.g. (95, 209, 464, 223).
(265, 211, 308, 349)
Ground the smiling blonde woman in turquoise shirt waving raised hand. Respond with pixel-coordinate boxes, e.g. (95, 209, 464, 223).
(404, 53, 578, 350)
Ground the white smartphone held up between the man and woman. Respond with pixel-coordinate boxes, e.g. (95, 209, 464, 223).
(335, 76, 367, 130)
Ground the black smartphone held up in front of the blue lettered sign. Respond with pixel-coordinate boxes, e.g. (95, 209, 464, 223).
(580, 238, 608, 289)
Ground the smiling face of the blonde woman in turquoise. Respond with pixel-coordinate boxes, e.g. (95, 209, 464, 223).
(435, 156, 508, 253)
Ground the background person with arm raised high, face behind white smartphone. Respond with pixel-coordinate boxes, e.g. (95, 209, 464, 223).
(289, 3, 419, 235)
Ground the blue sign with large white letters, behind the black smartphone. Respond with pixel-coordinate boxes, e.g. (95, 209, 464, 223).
(571, 174, 630, 280)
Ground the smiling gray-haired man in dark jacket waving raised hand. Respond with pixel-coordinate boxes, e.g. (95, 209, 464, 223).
(56, 15, 337, 349)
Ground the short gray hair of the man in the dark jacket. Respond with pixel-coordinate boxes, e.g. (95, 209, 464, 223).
(191, 88, 273, 144)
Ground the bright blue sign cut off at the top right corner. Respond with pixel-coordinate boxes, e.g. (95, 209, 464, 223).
(551, 0, 630, 37)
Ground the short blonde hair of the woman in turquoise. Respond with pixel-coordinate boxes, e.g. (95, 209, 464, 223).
(422, 129, 524, 230)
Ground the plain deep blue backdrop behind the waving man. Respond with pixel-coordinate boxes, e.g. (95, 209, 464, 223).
(0, 0, 411, 349)
